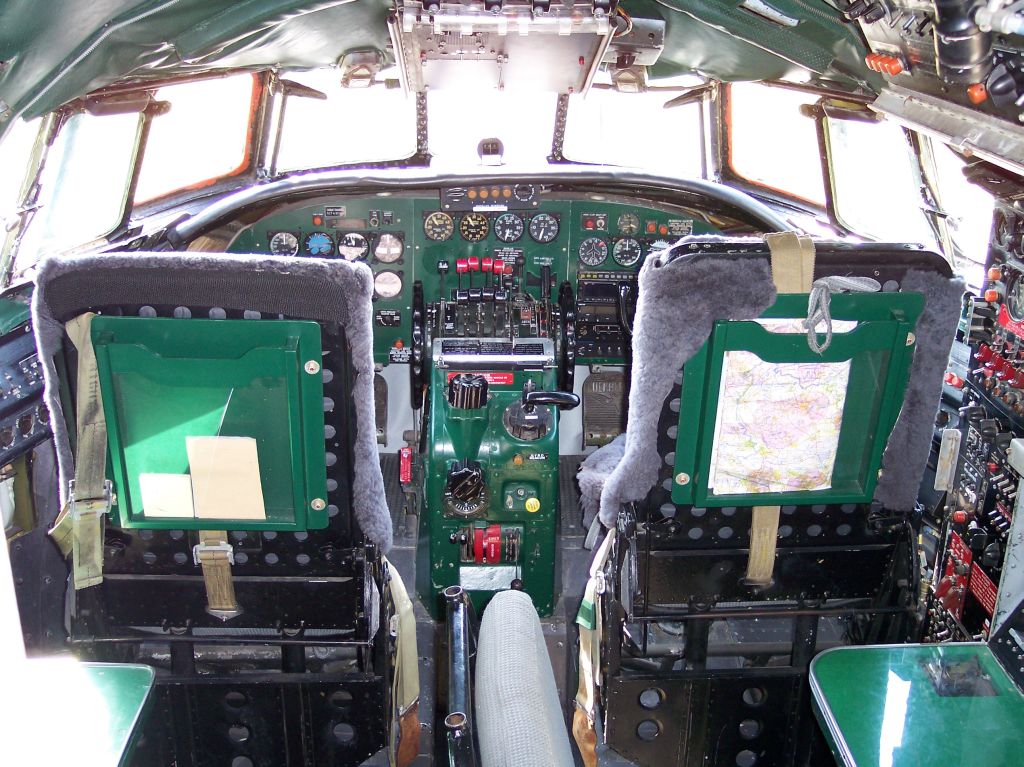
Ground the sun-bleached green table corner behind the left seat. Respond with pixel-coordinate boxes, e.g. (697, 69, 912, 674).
(0, 658, 155, 767)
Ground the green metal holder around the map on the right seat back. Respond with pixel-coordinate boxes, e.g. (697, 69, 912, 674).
(672, 293, 924, 506)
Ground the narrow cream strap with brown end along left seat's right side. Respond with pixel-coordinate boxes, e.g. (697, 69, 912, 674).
(381, 556, 420, 767)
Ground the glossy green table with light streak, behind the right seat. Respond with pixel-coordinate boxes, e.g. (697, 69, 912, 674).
(810, 642, 1024, 767)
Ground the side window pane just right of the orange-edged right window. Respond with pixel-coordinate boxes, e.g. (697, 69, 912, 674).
(825, 119, 936, 248)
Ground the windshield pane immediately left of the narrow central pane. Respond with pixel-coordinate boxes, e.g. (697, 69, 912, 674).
(278, 69, 416, 170)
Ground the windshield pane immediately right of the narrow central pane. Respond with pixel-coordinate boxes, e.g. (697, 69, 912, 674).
(562, 81, 703, 178)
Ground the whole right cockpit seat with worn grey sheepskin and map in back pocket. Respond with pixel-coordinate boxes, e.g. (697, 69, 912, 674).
(577, 235, 963, 767)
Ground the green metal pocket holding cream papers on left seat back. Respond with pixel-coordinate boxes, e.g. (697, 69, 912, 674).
(92, 316, 327, 530)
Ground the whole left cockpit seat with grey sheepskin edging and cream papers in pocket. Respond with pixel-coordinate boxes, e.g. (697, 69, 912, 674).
(34, 253, 420, 767)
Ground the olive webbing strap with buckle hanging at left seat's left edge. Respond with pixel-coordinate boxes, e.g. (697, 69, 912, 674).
(50, 312, 114, 590)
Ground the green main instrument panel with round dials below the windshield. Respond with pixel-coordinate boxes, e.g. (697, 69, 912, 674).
(228, 183, 719, 365)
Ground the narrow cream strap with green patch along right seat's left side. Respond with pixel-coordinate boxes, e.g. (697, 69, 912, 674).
(572, 529, 615, 767)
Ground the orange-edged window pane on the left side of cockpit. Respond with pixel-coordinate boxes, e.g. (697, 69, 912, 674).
(135, 75, 256, 202)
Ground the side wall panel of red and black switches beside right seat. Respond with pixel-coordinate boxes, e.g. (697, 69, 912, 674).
(937, 200, 1024, 642)
